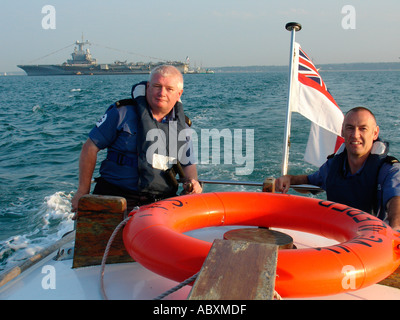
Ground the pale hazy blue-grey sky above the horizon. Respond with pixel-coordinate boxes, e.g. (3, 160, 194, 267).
(0, 0, 400, 72)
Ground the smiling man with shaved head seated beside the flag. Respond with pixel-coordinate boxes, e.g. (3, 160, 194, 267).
(275, 107, 400, 231)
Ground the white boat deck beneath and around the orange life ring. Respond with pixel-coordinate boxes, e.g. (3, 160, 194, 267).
(0, 227, 400, 300)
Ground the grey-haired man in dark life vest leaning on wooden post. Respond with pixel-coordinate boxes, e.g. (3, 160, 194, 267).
(72, 65, 202, 211)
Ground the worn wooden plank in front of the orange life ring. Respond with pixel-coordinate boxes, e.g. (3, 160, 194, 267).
(188, 239, 278, 300)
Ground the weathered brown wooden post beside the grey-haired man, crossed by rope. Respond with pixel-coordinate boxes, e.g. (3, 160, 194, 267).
(73, 195, 133, 268)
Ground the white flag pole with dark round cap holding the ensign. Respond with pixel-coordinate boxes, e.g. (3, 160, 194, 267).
(282, 22, 301, 175)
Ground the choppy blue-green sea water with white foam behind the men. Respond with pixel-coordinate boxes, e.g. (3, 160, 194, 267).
(0, 71, 400, 270)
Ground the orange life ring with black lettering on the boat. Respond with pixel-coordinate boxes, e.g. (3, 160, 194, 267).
(123, 192, 400, 297)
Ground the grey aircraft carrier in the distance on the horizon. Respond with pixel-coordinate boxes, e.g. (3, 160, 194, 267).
(18, 38, 189, 76)
